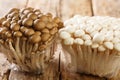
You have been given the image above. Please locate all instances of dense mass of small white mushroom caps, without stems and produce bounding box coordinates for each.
[59,16,120,51]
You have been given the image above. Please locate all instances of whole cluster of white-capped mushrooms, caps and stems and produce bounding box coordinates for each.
[59,15,120,78]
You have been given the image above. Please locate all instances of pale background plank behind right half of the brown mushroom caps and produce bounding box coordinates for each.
[27,0,59,16]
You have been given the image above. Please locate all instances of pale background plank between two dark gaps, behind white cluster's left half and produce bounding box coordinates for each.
[60,0,92,20]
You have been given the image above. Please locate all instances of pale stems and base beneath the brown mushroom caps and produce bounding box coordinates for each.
[0,38,56,74]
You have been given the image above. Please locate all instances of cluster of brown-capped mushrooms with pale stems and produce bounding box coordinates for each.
[0,7,63,73]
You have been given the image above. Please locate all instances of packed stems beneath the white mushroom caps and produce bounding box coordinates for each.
[62,44,120,78]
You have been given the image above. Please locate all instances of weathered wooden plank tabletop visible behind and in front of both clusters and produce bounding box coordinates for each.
[0,0,120,80]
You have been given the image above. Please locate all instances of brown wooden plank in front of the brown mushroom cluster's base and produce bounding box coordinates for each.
[9,63,59,80]
